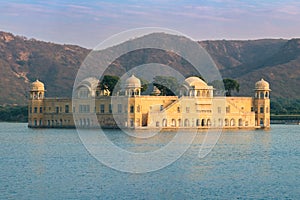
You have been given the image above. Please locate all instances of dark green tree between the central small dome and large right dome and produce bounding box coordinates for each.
[153,76,180,96]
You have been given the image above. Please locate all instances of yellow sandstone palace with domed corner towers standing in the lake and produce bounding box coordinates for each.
[28,75,271,129]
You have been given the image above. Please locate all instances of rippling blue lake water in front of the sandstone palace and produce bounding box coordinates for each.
[0,123,300,199]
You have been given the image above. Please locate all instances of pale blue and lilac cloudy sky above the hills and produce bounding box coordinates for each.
[0,0,300,48]
